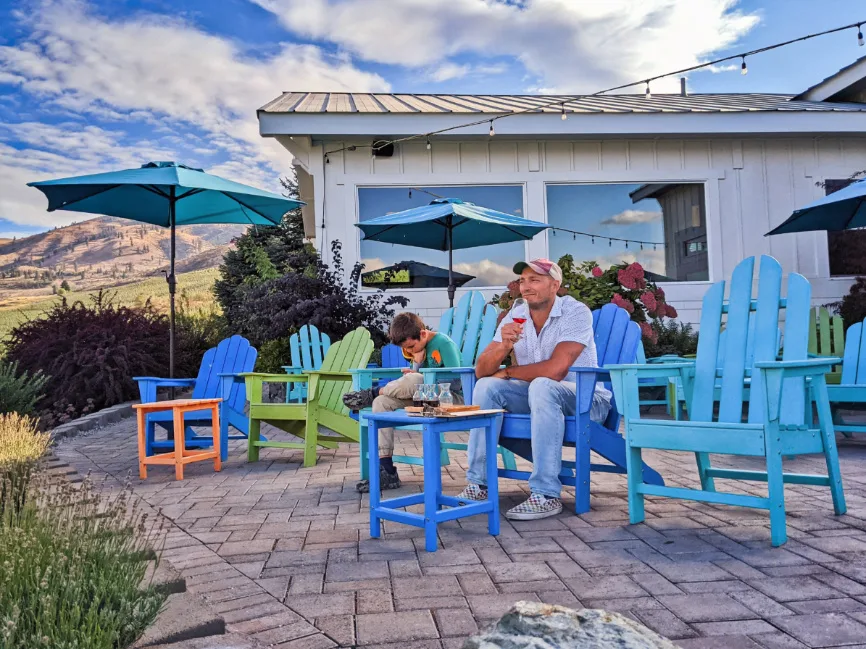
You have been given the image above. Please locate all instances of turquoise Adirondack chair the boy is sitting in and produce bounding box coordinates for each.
[353,291,517,479]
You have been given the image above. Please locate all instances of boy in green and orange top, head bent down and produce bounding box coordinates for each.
[343,312,463,493]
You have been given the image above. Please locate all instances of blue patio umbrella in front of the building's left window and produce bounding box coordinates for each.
[355,198,550,306]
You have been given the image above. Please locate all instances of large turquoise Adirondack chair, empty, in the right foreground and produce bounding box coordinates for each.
[608,256,845,546]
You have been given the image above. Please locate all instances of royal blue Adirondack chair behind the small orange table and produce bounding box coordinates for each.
[133,336,258,461]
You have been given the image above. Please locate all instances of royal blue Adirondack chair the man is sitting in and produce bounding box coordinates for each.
[464,304,664,514]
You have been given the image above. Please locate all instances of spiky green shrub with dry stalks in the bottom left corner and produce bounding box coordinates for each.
[0,470,165,649]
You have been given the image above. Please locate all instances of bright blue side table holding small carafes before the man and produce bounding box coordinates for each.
[365,410,502,552]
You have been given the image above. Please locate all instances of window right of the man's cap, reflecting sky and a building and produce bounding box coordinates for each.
[547,183,710,282]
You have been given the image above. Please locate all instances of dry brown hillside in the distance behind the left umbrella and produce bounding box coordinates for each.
[0,217,245,309]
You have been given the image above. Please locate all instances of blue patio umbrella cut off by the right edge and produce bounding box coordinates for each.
[764,180,866,236]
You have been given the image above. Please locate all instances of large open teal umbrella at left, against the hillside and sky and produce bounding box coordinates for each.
[27,162,303,377]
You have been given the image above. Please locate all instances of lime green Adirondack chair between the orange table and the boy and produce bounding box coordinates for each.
[244,327,373,467]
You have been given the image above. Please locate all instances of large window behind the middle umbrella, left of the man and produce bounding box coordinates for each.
[358,185,526,288]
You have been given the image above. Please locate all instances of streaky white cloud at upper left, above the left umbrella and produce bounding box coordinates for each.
[0,0,389,224]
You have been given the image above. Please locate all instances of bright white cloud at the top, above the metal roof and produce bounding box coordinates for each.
[253,0,758,92]
